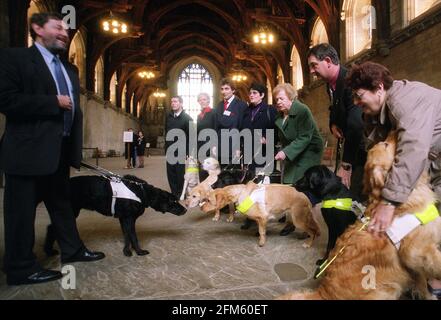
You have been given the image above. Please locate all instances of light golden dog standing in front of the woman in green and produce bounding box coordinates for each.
[201,182,320,247]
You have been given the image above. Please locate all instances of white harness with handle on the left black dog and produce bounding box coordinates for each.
[81,162,144,216]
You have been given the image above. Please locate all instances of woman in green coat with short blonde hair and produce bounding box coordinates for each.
[274,83,324,184]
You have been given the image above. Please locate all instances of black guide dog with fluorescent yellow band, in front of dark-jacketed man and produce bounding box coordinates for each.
[294,165,357,265]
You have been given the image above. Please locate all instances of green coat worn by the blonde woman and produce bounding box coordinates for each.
[276,100,324,184]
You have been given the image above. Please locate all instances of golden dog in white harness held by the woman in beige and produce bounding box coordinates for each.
[365,131,441,299]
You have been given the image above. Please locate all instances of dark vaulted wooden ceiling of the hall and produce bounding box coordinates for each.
[12,0,340,109]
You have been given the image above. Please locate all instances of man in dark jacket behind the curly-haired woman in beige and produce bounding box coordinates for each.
[308,43,366,200]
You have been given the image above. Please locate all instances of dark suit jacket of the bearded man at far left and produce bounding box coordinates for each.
[0,46,83,175]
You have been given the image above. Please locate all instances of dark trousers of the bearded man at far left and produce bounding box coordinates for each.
[4,142,84,277]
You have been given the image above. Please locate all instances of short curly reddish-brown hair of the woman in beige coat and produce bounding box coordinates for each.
[346,61,394,91]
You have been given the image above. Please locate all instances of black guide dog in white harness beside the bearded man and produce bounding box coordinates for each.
[44,175,187,257]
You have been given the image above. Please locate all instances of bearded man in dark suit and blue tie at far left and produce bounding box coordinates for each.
[0,13,104,285]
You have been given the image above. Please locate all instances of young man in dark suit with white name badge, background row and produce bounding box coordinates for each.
[215,78,247,165]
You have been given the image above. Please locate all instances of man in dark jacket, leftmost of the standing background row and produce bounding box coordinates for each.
[165,96,193,198]
